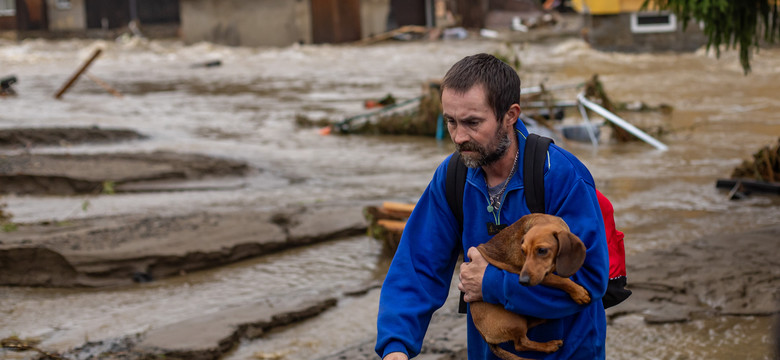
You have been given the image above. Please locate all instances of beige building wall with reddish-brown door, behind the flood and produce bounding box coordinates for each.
[180,0,434,46]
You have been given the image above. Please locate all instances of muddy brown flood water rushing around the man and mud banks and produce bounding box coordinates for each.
[0,34,780,359]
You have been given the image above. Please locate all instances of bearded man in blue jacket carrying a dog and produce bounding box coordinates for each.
[376,54,609,360]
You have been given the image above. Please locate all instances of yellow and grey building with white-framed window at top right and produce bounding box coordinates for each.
[572,0,707,52]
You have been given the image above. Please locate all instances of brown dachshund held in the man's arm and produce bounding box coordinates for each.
[470,214,590,360]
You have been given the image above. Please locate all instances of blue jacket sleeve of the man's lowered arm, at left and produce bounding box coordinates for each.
[375,161,461,356]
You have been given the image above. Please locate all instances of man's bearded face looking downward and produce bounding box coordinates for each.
[441,85,512,168]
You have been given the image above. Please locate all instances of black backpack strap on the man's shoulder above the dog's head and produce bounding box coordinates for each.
[523,134,553,213]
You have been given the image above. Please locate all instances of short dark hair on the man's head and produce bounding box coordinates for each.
[441,53,520,123]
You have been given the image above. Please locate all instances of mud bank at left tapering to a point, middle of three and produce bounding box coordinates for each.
[0,148,250,195]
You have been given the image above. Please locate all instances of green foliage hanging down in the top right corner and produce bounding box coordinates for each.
[643,0,780,74]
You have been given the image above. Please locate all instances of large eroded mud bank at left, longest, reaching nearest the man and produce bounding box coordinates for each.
[0,204,366,287]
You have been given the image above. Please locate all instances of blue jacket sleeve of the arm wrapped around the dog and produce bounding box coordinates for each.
[482,151,609,319]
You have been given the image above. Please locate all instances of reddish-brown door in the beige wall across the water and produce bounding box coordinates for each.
[311,0,360,44]
